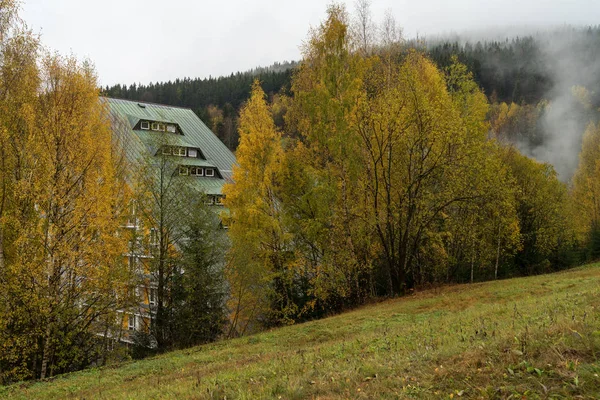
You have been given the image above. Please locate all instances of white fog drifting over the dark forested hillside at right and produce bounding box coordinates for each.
[428,26,600,182]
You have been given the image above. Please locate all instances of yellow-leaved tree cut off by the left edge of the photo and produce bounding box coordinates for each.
[0,0,40,382]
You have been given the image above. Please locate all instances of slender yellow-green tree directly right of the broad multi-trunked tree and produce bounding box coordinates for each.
[446,56,521,282]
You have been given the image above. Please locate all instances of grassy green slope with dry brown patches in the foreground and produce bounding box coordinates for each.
[0,265,600,399]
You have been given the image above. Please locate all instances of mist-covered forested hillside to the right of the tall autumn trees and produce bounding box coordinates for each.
[428,27,600,181]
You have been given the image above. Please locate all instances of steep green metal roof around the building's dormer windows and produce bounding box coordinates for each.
[104,98,236,194]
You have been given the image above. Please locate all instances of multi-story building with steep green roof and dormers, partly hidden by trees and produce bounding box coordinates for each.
[105,98,236,342]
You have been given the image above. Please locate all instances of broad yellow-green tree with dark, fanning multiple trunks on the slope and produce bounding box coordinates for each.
[359,52,502,293]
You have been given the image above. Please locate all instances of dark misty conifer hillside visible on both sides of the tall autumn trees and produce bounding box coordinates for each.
[104,26,600,182]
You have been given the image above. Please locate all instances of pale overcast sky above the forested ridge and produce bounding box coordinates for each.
[22,0,600,85]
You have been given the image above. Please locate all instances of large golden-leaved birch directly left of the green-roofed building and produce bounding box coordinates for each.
[0,56,129,380]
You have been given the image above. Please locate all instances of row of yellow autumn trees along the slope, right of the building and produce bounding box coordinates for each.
[224,5,598,334]
